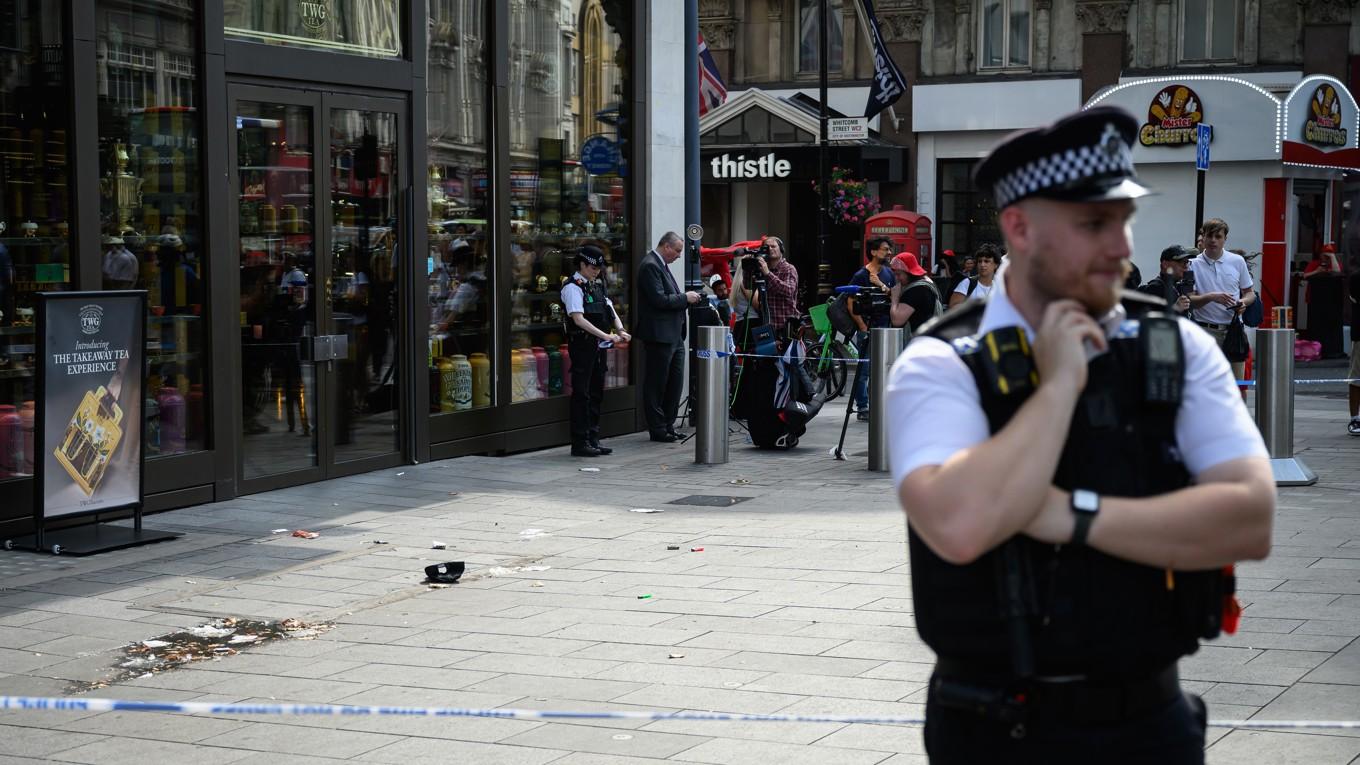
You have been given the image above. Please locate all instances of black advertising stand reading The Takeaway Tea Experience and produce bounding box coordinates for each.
[4,290,181,555]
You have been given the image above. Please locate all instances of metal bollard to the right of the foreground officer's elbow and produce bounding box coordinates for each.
[1257,329,1318,486]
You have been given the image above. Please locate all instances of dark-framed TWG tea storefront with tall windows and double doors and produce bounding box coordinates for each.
[0,0,656,535]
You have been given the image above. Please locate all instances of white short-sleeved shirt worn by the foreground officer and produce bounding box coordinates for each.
[887,274,1269,485]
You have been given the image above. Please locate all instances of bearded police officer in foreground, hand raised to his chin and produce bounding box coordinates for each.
[888,108,1276,764]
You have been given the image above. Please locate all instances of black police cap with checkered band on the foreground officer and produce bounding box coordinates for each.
[972,106,1152,210]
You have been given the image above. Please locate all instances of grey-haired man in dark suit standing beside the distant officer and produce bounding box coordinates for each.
[634,231,700,444]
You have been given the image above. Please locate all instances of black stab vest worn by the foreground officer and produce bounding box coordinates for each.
[907,293,1231,677]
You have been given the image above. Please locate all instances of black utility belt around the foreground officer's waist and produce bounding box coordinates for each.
[930,657,1180,724]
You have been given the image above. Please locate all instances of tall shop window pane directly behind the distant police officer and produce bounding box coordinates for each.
[498,0,632,402]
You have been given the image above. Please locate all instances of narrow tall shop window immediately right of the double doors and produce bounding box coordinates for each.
[426,0,496,412]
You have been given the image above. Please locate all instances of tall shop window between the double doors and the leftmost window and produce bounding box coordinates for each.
[95,0,209,457]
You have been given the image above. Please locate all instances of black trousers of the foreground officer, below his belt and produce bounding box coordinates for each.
[925,683,1206,765]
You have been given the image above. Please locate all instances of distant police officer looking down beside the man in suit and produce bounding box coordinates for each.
[562,245,631,457]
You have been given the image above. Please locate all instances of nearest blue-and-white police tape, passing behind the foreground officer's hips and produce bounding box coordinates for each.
[0,696,1360,730]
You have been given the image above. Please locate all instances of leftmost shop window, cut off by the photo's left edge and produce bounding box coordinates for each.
[0,0,71,481]
